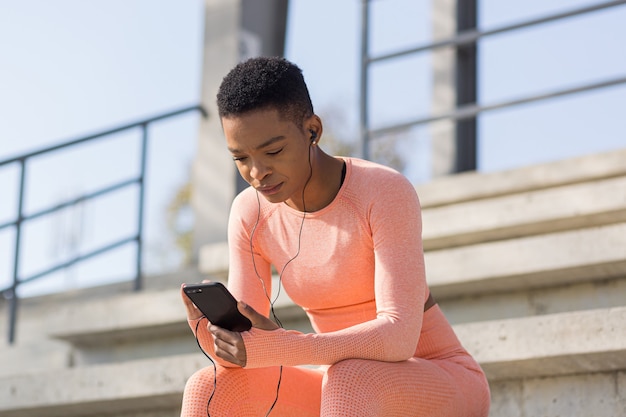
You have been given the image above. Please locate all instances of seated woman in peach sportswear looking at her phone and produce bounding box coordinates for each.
[182,58,489,417]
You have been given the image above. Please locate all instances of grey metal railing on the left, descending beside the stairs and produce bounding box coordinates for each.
[0,105,207,344]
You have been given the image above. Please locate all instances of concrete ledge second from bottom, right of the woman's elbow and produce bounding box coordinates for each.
[425,223,626,299]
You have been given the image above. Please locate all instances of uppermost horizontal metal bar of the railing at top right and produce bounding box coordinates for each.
[366,0,626,62]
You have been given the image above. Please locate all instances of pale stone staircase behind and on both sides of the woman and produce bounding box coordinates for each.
[0,150,626,417]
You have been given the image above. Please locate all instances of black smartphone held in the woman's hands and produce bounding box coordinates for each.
[183,282,252,332]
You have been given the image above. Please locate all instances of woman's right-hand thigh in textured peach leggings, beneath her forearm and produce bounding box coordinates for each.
[322,358,489,417]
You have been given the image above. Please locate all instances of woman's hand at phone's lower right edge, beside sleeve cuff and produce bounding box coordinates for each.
[208,301,278,367]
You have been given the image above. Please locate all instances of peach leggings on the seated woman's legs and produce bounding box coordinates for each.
[181,357,489,417]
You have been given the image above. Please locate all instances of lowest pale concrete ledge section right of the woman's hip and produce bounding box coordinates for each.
[454,307,626,381]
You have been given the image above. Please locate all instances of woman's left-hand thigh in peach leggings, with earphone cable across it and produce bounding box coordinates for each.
[181,367,323,417]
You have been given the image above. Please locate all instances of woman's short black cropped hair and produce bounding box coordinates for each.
[217,57,313,127]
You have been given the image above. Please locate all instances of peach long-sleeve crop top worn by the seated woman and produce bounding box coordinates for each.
[192,158,468,368]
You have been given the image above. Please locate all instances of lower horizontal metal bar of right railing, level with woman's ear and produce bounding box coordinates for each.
[369,76,626,137]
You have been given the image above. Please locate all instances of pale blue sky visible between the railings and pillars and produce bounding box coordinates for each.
[0,0,626,294]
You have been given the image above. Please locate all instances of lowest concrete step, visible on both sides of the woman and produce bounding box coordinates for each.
[0,307,626,417]
